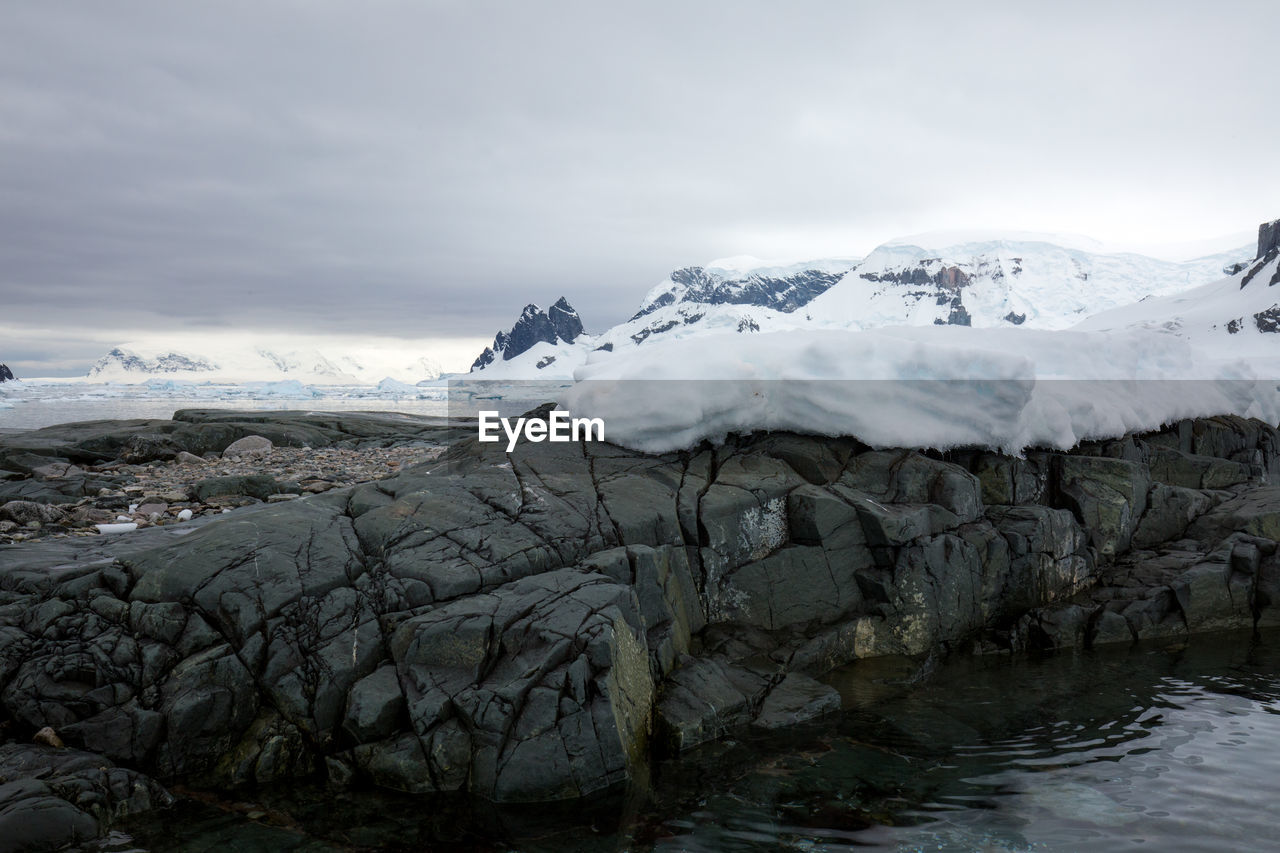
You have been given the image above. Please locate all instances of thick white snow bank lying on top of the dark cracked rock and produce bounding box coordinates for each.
[558,327,1280,453]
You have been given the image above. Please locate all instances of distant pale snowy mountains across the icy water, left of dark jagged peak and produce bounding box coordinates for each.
[88,341,440,384]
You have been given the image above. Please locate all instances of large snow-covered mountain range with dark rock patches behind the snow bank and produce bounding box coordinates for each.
[472,225,1253,379]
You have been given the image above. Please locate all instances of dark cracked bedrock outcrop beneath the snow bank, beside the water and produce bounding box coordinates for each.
[0,418,1280,802]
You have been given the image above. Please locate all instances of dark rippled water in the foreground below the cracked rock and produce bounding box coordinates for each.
[113,633,1280,853]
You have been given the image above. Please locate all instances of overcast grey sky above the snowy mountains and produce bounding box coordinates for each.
[0,0,1280,375]
